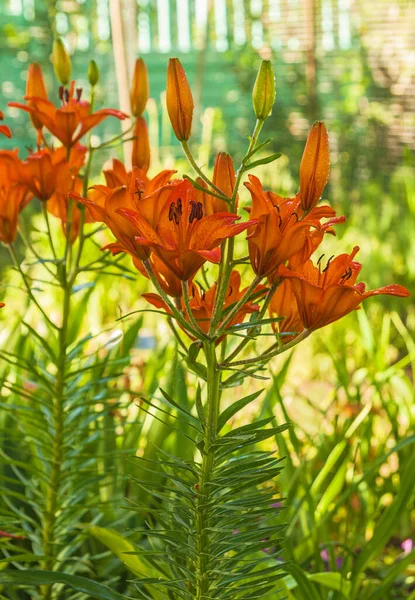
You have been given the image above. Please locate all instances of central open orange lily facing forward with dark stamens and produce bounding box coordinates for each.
[118,180,253,281]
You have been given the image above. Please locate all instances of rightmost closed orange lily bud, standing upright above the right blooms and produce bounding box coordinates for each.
[300,121,330,212]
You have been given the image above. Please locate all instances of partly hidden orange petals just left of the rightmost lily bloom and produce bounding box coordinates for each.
[269,279,304,343]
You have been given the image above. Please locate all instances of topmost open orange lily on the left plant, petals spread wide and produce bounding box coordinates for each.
[9,81,127,148]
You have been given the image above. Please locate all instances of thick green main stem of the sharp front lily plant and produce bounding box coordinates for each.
[195,342,221,600]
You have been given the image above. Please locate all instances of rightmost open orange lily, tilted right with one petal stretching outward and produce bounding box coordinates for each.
[278,246,409,330]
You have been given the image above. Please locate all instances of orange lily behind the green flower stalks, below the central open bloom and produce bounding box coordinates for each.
[143,271,265,343]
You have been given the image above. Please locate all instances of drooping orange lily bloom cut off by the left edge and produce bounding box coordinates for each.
[0,150,30,244]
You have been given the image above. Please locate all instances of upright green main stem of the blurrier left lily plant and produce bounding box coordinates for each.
[42,284,72,600]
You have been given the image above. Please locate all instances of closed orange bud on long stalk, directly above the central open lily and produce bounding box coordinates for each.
[166,58,194,142]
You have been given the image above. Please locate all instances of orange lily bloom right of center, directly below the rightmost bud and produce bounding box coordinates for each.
[245,175,336,277]
